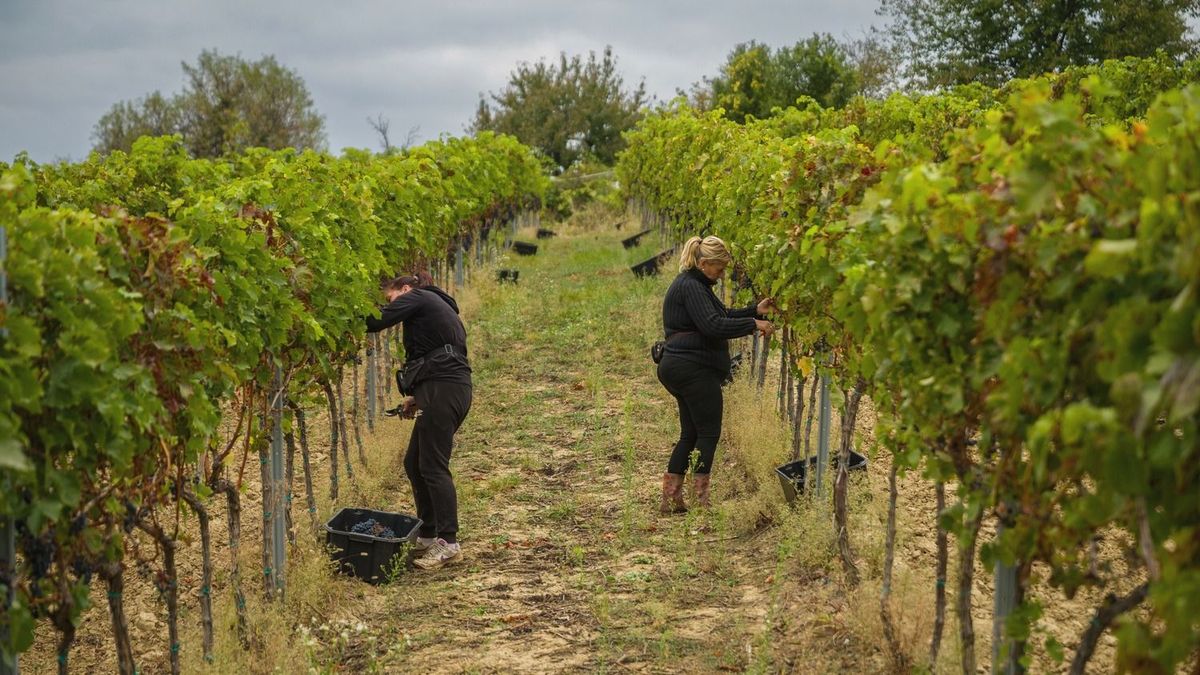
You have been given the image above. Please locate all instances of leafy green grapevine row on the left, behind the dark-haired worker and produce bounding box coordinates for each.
[0,133,546,671]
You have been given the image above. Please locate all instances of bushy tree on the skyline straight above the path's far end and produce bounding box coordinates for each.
[470,47,647,169]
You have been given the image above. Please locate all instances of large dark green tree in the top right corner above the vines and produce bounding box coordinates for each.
[880,0,1200,88]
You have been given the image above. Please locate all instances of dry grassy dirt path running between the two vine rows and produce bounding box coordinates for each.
[343,224,782,671]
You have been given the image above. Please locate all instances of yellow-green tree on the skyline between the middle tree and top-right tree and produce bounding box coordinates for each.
[692,34,882,123]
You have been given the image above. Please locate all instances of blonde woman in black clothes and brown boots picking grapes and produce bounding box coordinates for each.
[659,237,775,513]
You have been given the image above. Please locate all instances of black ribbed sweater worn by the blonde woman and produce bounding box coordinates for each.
[662,268,757,376]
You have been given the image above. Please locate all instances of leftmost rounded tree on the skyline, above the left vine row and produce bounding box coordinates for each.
[92,50,325,157]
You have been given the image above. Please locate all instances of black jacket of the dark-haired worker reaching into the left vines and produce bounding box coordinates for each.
[366,286,470,384]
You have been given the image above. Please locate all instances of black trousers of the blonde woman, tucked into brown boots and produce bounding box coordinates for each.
[659,354,725,473]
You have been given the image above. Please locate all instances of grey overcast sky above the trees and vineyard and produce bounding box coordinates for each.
[0,0,880,161]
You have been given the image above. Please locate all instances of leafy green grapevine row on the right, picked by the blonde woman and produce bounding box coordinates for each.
[617,59,1200,671]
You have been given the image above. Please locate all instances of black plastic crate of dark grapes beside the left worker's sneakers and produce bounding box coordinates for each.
[325,508,421,584]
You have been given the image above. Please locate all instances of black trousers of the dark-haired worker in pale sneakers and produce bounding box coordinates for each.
[404,380,472,542]
